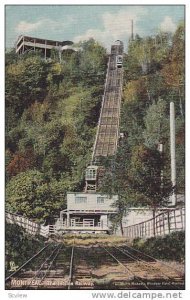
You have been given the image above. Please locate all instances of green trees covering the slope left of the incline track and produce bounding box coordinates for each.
[6,40,107,222]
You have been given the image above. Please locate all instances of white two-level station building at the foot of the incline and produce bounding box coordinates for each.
[56,193,118,233]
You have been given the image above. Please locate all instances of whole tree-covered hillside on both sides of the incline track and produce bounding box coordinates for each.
[6,25,185,222]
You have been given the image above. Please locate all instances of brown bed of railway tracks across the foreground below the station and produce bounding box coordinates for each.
[6,242,184,290]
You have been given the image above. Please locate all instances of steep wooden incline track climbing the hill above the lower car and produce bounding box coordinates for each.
[92,41,123,162]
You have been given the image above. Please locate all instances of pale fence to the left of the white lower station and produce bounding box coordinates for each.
[5,212,51,237]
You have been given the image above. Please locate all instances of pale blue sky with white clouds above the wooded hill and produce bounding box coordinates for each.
[5,5,184,48]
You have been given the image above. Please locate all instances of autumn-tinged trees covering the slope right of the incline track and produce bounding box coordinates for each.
[102,25,184,223]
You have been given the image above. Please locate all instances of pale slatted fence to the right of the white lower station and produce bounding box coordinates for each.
[123,208,185,239]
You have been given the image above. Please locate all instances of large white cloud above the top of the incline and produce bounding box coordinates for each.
[74,7,147,47]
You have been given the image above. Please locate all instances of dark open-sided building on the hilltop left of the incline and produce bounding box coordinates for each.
[15,35,77,59]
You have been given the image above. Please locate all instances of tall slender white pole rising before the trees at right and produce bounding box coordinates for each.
[170,102,177,206]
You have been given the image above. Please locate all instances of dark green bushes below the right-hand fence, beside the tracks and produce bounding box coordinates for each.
[132,231,185,261]
